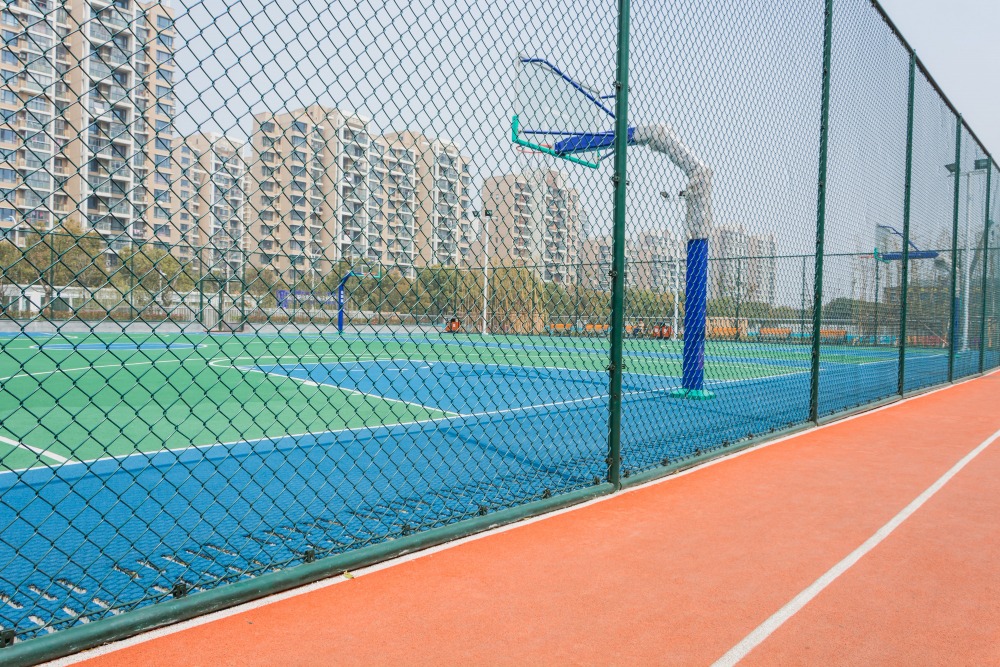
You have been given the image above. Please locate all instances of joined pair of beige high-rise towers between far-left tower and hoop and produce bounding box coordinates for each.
[246,106,477,282]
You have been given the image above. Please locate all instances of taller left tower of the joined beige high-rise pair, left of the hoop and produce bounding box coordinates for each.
[245,105,366,283]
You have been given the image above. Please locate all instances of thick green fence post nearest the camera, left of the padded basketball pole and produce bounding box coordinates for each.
[608,0,629,489]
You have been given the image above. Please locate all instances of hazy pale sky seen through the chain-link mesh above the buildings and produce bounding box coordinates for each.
[162,0,1000,306]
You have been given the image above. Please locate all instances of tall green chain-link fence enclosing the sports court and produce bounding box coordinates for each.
[0,0,1000,662]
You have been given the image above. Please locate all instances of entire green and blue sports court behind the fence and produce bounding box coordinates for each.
[0,331,978,636]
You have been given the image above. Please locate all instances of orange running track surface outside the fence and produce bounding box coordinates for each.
[58,375,1000,667]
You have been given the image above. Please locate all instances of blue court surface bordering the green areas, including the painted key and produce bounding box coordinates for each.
[0,341,996,637]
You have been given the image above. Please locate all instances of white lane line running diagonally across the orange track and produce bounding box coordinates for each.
[713,431,1000,667]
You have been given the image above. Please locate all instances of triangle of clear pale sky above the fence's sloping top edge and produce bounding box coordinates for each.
[882,0,1000,153]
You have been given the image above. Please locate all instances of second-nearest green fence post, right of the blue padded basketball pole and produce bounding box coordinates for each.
[809,0,833,421]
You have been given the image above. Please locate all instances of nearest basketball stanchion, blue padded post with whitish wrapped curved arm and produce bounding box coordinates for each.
[630,125,716,399]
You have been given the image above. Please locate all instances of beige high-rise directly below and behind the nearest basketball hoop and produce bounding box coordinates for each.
[482,169,588,283]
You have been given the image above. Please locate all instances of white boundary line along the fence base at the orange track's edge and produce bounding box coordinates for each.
[45,369,1000,667]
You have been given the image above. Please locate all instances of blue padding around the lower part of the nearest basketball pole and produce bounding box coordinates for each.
[672,239,715,399]
